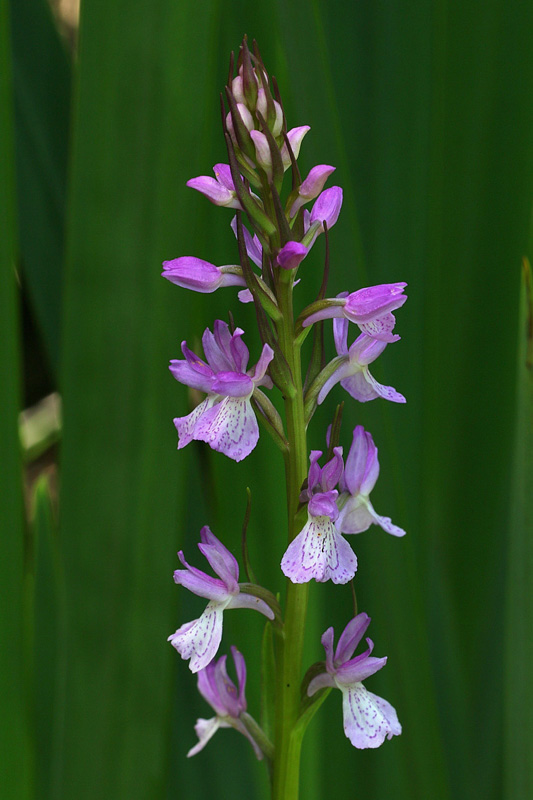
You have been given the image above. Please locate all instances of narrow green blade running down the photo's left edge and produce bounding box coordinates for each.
[0,2,33,800]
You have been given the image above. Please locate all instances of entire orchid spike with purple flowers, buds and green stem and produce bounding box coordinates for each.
[163,39,407,798]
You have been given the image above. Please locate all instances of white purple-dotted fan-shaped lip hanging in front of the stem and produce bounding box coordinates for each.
[281,516,357,583]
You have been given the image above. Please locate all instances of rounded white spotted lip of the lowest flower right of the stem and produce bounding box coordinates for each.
[342,683,401,749]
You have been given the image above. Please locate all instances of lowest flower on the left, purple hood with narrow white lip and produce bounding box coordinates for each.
[187,647,263,759]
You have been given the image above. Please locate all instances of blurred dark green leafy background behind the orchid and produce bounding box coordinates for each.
[0,0,533,800]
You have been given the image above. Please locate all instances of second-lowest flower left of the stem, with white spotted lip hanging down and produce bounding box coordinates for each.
[168,525,274,672]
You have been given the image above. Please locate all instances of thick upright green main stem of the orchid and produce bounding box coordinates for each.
[272,273,309,800]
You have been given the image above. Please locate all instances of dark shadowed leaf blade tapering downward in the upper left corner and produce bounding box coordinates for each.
[11,0,71,376]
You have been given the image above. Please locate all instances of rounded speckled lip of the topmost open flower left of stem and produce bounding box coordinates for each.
[194,397,259,461]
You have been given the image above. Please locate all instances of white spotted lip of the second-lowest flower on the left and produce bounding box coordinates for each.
[168,600,227,672]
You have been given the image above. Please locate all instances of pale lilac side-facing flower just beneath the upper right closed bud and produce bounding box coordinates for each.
[317,318,405,405]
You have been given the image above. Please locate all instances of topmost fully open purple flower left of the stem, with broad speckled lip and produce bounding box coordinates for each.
[170,320,274,461]
